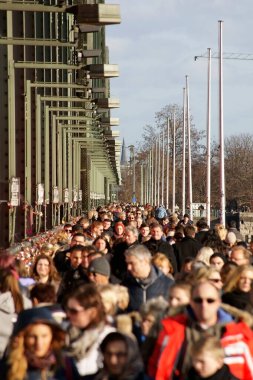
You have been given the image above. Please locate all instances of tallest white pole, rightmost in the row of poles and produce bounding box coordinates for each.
[219,21,226,226]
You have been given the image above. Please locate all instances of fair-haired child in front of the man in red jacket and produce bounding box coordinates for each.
[186,336,238,380]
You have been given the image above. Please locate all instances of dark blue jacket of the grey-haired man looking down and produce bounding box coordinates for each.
[122,265,174,311]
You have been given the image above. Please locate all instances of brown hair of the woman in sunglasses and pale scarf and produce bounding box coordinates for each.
[66,284,106,326]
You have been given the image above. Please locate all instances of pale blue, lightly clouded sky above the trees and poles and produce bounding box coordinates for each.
[106,0,253,145]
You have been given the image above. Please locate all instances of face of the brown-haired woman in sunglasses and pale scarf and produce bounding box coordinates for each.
[66,298,96,329]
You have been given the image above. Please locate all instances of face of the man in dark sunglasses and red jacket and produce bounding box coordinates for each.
[190,283,221,326]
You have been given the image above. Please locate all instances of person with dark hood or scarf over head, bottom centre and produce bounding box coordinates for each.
[95,331,147,380]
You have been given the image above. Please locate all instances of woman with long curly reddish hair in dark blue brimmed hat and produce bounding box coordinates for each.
[0,308,77,380]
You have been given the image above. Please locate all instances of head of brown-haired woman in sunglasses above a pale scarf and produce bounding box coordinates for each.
[65,284,105,329]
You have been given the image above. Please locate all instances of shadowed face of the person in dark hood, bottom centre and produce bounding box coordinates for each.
[104,341,127,376]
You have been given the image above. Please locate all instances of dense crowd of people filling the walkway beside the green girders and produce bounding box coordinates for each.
[0,203,253,380]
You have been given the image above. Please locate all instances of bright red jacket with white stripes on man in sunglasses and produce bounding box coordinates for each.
[148,314,253,380]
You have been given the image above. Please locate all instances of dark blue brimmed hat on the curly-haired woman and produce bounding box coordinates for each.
[12,307,63,336]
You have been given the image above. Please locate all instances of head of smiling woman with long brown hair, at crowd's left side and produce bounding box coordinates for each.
[32,255,60,292]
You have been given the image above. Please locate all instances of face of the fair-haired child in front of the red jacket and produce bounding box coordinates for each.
[192,351,223,378]
